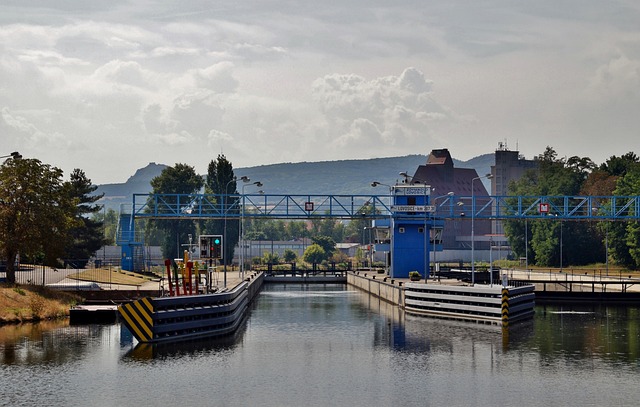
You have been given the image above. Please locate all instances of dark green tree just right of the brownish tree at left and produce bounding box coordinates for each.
[65,168,105,268]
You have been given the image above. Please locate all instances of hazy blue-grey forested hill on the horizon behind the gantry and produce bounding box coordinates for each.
[96,154,494,210]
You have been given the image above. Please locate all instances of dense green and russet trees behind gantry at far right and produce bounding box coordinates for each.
[504,147,640,269]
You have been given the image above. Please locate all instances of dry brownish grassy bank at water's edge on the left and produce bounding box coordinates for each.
[0,285,82,324]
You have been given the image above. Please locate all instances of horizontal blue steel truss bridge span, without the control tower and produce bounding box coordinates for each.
[123,194,640,221]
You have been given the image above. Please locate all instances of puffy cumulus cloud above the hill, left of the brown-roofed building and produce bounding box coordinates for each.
[312,68,455,151]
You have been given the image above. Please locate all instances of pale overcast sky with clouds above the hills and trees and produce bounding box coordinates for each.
[0,0,640,184]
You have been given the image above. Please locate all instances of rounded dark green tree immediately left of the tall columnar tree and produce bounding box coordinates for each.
[149,164,204,259]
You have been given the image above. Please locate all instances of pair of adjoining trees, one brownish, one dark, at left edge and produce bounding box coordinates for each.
[0,158,104,283]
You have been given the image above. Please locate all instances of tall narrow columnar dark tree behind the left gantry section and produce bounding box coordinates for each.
[202,154,240,264]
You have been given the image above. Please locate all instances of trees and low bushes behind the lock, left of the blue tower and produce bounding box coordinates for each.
[144,154,370,264]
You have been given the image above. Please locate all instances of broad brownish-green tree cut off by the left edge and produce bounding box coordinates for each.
[0,159,78,283]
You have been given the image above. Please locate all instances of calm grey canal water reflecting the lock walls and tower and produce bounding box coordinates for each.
[0,285,640,407]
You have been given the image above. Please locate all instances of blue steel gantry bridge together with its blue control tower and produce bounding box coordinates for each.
[118,190,640,278]
